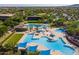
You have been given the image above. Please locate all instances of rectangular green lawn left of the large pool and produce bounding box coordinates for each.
[4,34,23,48]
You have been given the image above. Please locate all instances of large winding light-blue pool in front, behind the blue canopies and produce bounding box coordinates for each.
[24,34,74,55]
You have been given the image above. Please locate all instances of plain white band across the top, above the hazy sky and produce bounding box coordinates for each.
[0,0,79,5]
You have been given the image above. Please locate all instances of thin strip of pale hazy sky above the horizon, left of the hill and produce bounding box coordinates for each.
[0,4,72,7]
